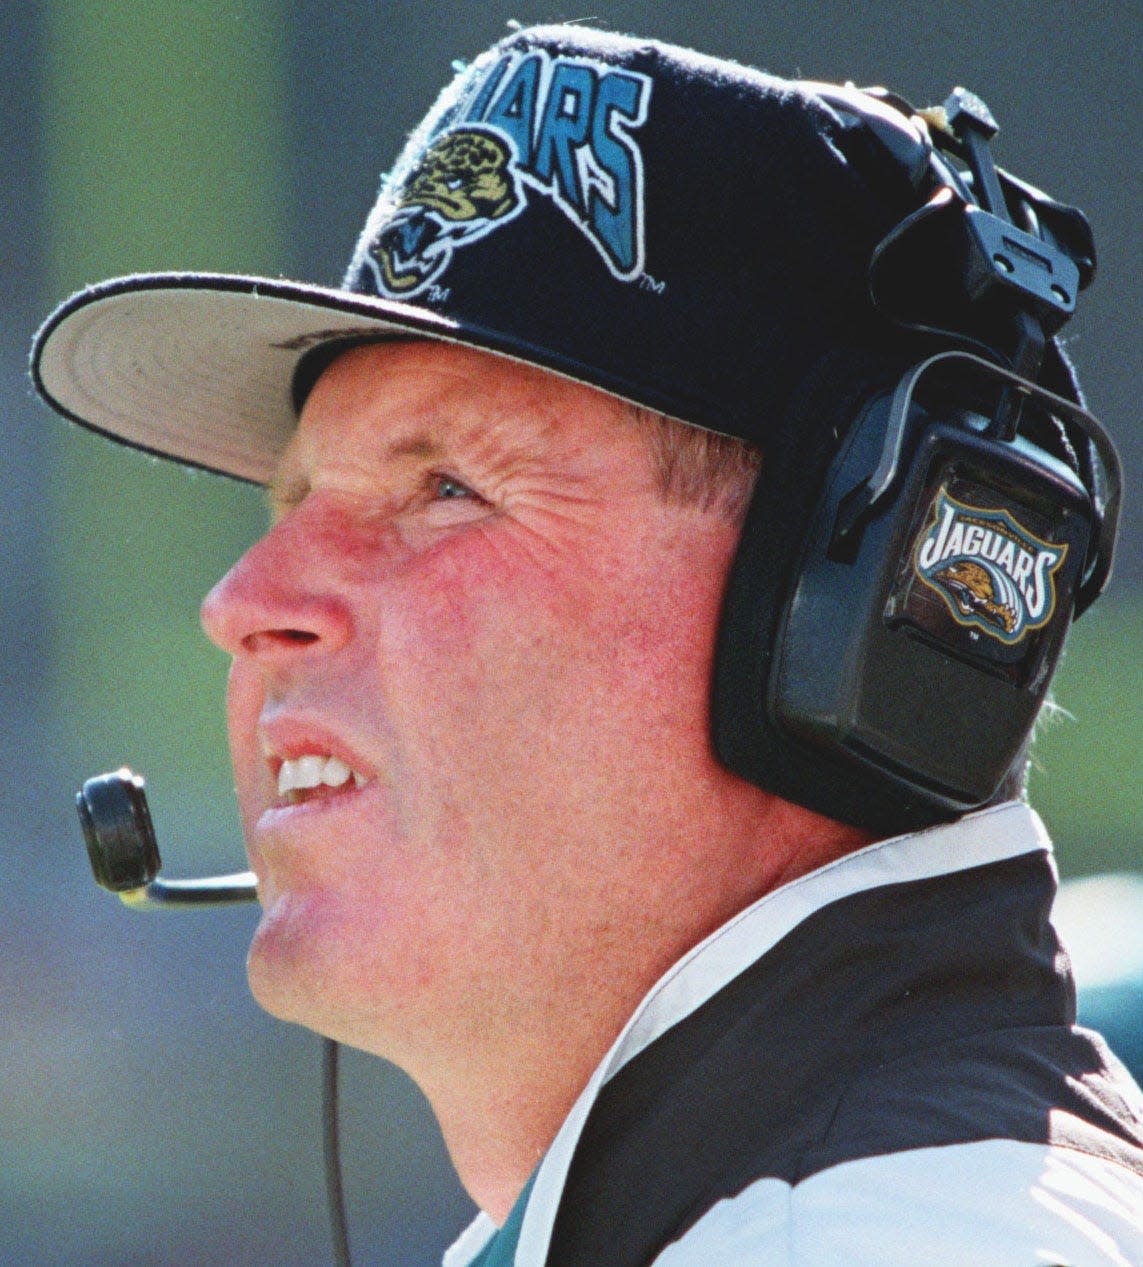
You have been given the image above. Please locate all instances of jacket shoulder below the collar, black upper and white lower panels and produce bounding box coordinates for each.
[655,1026,1143,1267]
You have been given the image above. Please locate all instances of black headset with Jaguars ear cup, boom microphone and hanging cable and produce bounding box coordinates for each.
[77,84,1121,1264]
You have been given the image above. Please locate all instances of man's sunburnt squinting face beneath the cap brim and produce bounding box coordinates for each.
[204,342,736,1068]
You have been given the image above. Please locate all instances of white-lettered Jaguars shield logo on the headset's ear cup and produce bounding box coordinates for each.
[914,487,1068,646]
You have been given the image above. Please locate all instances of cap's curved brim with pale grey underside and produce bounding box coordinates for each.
[32,274,558,484]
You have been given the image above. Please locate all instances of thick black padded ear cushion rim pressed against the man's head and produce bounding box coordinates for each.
[712,348,949,836]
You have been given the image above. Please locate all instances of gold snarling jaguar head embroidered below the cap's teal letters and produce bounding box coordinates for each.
[369,127,523,298]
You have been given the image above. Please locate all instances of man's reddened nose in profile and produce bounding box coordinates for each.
[201,516,352,666]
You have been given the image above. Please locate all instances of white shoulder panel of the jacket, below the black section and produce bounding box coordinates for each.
[655,1139,1143,1267]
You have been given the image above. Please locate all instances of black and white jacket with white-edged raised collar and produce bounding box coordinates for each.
[445,803,1143,1267]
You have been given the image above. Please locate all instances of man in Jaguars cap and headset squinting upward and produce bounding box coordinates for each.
[35,19,1143,1267]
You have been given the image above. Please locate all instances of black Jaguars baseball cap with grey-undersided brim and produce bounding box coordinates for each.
[32,25,921,483]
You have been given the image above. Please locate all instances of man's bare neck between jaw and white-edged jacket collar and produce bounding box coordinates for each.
[409,801,868,1225]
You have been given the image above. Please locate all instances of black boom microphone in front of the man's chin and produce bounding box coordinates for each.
[76,767,257,911]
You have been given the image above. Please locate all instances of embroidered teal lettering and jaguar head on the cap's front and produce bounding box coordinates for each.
[365,49,651,299]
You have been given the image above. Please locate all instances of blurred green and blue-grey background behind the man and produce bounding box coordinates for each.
[0,0,1143,1267]
